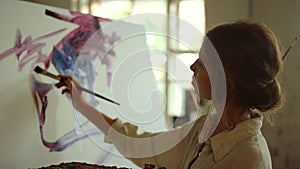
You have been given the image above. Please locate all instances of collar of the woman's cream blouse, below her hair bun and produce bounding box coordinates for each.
[209,117,263,162]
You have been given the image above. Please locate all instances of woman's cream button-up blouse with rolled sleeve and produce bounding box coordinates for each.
[105,117,272,169]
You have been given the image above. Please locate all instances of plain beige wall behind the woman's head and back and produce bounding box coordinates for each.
[206,0,300,169]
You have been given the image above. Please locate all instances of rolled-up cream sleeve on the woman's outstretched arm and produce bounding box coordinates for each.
[104,119,202,169]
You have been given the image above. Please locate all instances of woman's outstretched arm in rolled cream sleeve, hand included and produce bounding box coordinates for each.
[56,76,204,168]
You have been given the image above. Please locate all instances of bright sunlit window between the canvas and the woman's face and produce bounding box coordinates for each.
[72,0,205,125]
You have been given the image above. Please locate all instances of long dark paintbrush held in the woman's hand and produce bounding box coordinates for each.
[34,66,120,105]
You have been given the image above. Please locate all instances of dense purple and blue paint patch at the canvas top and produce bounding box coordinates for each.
[45,10,120,86]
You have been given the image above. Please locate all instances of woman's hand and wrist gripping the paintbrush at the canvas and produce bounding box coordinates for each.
[55,75,88,111]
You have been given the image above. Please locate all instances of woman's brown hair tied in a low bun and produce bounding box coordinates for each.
[206,21,283,117]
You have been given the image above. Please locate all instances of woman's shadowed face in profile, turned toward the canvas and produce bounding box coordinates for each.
[190,58,211,99]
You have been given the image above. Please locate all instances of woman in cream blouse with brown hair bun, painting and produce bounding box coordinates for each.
[56,21,282,169]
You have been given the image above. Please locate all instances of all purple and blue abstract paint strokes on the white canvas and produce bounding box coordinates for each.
[0,10,120,155]
